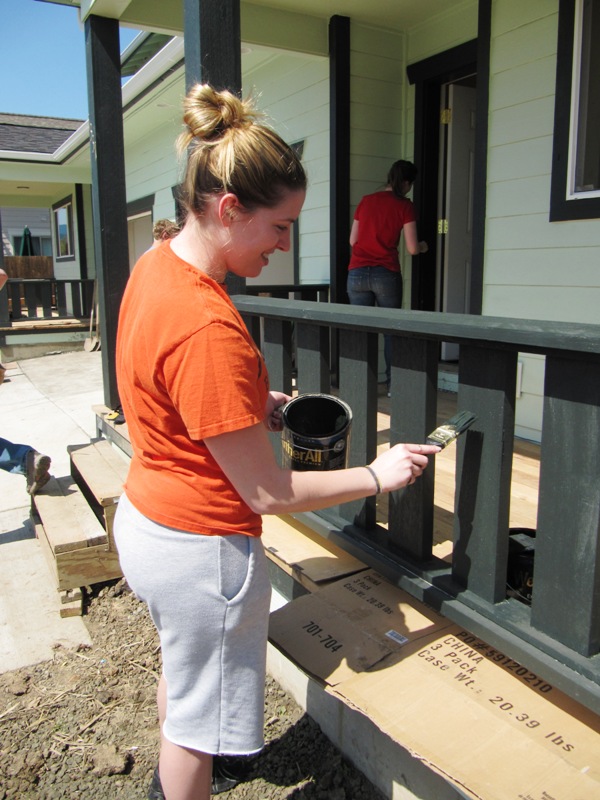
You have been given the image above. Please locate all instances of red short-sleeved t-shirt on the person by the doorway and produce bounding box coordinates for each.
[348,191,416,272]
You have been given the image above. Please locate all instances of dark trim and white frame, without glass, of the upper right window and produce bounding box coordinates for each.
[550,0,600,222]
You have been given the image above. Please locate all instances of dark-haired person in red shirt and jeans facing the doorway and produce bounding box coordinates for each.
[347,161,428,395]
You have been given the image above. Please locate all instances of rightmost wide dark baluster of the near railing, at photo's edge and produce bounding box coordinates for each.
[531,356,600,656]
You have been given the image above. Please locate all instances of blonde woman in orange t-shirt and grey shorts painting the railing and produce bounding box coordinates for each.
[115,85,438,800]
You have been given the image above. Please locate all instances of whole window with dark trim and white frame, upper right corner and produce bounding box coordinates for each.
[550,0,600,220]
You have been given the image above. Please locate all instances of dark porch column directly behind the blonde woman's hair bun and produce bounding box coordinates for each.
[183,0,246,295]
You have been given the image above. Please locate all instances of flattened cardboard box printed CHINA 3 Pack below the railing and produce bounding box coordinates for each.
[270,570,600,800]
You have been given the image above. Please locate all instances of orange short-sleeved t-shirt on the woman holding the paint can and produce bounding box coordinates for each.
[117,241,269,536]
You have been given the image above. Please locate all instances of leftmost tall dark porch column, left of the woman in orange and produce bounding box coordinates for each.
[85,15,129,408]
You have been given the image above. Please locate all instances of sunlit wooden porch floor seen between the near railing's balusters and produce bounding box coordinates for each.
[377,391,540,558]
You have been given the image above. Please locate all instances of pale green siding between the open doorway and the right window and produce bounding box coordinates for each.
[483,0,600,440]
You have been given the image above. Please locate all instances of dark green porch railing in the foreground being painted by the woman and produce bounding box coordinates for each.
[233,296,600,713]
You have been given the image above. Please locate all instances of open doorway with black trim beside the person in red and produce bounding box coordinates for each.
[407,36,489,328]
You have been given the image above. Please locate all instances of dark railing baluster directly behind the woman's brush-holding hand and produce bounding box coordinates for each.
[388,336,439,561]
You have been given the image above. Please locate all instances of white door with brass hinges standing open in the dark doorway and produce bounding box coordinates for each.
[436,76,476,361]
